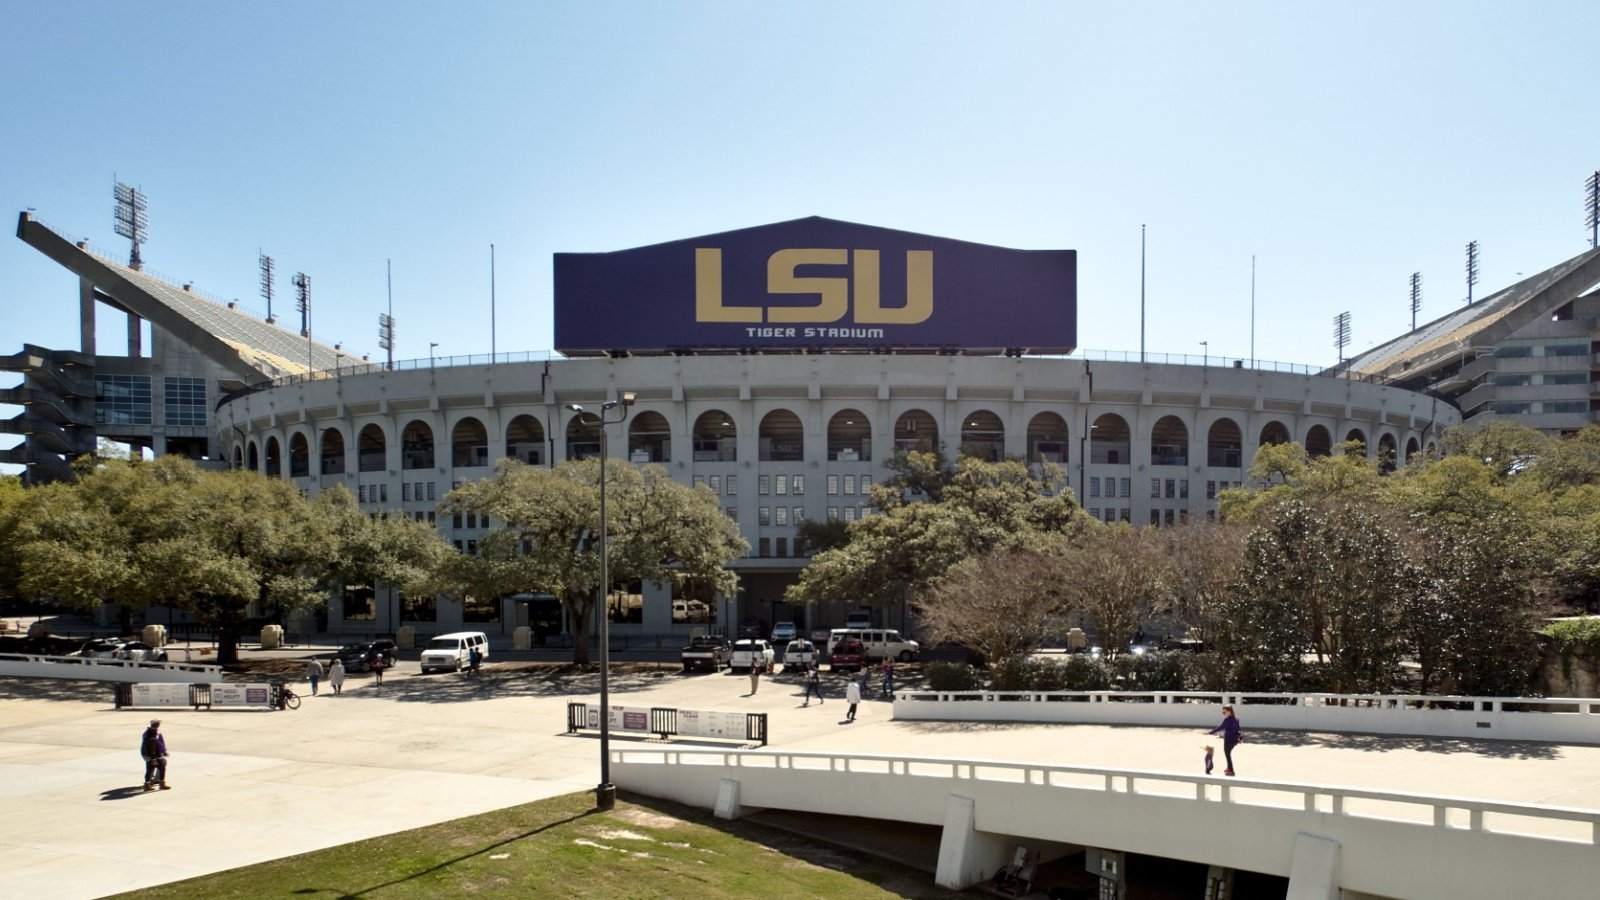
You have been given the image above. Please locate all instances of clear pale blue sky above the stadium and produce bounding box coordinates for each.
[0,0,1600,374]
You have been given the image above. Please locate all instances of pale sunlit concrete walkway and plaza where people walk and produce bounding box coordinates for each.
[0,661,1600,898]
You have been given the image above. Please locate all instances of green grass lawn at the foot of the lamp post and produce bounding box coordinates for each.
[122,791,958,900]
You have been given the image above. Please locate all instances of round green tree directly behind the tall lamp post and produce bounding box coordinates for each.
[443,460,750,663]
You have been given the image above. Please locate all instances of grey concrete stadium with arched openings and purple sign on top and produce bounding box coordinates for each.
[0,213,1548,641]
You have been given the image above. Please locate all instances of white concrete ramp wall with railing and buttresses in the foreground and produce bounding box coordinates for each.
[611,749,1600,900]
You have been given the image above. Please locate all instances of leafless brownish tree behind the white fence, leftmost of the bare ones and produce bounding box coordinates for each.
[922,549,1066,666]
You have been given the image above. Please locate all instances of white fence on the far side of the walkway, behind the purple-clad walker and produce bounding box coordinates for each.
[894,690,1600,745]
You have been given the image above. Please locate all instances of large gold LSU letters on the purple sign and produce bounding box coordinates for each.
[694,247,933,325]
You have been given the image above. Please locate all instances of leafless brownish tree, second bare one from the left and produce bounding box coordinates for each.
[1056,522,1176,657]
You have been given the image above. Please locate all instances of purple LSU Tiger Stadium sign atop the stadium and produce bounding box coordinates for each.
[555,218,1078,356]
